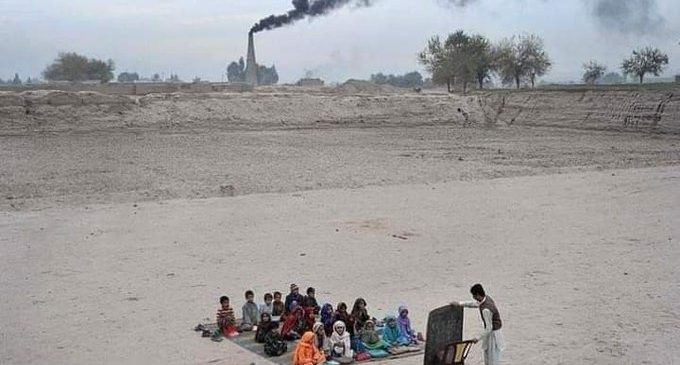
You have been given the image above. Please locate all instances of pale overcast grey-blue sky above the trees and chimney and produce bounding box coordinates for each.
[0,0,680,82]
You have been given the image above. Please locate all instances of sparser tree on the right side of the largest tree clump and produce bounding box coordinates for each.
[495,34,552,89]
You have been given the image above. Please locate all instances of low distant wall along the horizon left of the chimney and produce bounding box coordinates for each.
[0,82,253,95]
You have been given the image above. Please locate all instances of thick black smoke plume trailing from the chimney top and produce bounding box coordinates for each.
[250,0,373,33]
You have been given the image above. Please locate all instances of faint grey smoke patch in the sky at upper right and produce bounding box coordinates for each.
[591,0,664,34]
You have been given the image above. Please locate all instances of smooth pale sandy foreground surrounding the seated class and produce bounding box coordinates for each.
[0,167,680,364]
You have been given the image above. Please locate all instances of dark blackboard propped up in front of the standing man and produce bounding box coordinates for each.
[424,305,463,365]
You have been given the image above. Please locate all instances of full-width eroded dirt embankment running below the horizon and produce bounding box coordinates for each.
[0,85,680,135]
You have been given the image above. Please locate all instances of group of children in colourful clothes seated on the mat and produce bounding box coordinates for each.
[213,284,423,365]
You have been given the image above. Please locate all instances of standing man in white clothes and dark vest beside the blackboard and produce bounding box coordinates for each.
[451,284,505,365]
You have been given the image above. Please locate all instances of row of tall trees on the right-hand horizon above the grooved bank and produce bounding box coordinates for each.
[418,30,668,92]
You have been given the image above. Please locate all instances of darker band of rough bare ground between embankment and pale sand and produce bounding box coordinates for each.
[0,125,680,211]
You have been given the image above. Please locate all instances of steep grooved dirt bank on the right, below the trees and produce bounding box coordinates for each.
[476,88,680,134]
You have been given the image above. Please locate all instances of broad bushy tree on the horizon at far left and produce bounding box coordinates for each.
[43,52,115,83]
